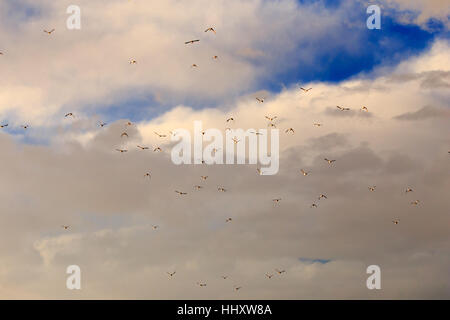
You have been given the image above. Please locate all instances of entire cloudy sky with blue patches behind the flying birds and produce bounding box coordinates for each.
[0,0,450,299]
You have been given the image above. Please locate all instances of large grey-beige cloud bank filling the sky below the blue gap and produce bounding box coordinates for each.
[0,38,450,299]
